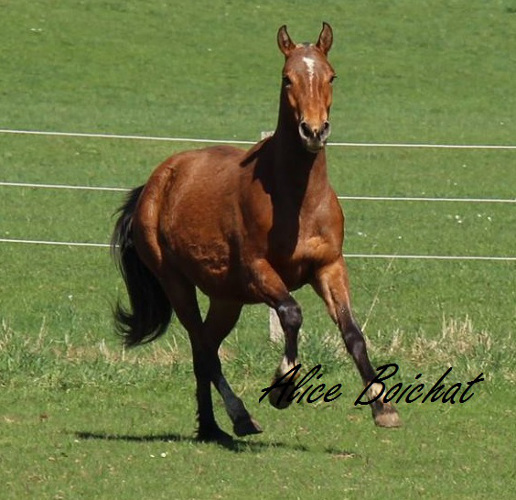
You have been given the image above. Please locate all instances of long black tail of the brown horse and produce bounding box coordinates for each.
[111,186,172,347]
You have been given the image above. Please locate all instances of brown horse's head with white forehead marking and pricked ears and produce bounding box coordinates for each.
[278,23,335,153]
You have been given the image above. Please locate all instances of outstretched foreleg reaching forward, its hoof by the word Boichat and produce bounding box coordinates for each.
[313,259,401,427]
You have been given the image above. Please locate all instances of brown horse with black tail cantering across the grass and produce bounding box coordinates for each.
[113,23,399,440]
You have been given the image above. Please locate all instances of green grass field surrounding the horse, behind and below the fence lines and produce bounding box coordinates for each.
[0,0,516,500]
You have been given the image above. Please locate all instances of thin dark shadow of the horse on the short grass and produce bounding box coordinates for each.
[73,431,357,457]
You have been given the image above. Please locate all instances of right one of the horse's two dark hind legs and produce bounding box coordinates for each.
[202,299,262,436]
